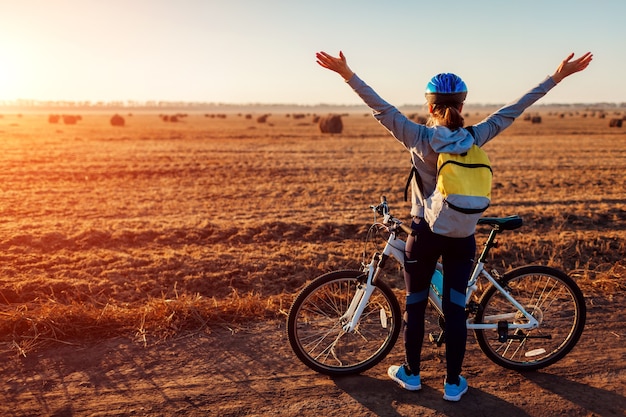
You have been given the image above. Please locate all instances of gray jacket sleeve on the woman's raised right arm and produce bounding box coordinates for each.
[473,77,556,146]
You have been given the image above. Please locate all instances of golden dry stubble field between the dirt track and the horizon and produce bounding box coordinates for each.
[0,111,626,353]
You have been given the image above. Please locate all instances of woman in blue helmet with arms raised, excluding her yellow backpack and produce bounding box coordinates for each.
[316,48,593,401]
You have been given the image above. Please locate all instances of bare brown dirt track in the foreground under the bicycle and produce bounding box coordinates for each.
[0,292,626,417]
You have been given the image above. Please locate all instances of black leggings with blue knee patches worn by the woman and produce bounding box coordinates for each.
[404,220,476,383]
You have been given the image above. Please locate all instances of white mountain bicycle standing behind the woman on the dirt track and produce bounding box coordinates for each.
[287,197,586,376]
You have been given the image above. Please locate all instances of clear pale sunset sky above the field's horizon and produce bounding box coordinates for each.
[0,0,626,106]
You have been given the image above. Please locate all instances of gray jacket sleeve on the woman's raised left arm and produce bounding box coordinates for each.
[347,74,429,153]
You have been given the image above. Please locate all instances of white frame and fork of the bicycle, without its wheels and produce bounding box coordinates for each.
[341,218,539,332]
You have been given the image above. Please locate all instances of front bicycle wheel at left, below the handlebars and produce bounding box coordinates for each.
[287,270,401,375]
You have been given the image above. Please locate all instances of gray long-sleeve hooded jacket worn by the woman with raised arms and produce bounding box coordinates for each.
[347,74,556,217]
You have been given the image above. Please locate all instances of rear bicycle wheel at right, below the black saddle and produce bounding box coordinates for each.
[475,266,586,371]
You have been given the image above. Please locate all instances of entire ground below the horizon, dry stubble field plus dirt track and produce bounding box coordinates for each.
[0,110,626,416]
